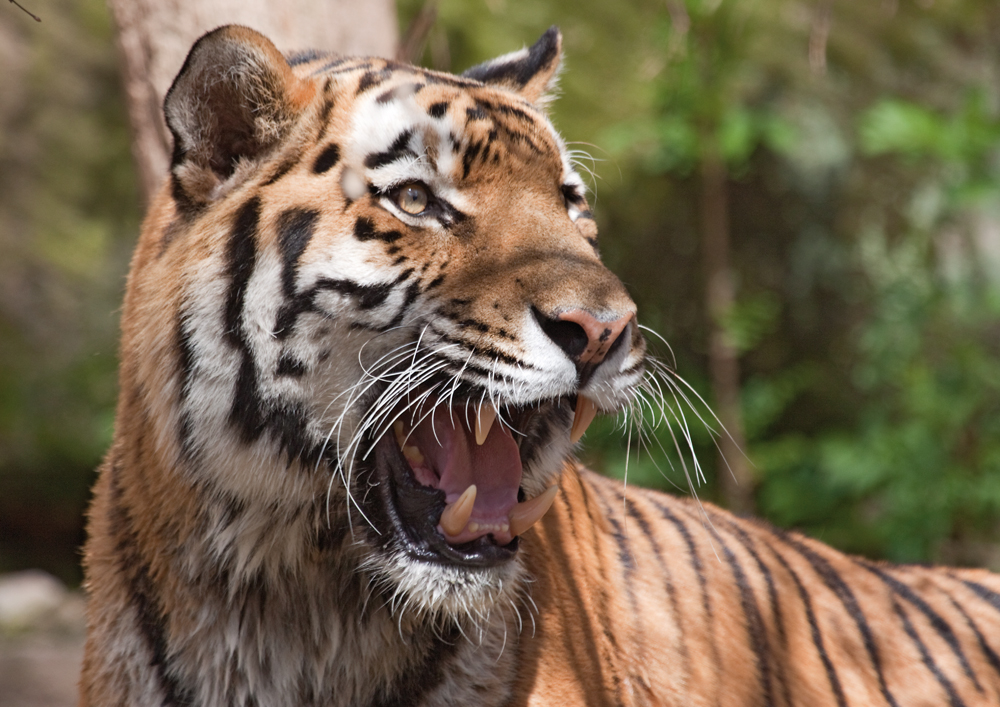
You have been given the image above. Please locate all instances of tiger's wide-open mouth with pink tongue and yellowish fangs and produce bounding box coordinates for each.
[375,396,596,567]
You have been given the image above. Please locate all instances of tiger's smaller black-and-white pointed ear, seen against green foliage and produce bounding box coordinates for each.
[462,25,562,104]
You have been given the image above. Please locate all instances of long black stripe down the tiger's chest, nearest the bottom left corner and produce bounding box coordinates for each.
[108,463,194,707]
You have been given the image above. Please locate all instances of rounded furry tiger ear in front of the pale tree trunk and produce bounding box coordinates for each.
[163,25,315,204]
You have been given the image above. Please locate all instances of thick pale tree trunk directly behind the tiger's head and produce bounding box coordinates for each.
[108,0,398,203]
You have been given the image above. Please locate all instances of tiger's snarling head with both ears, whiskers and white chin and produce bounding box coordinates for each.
[129,26,645,612]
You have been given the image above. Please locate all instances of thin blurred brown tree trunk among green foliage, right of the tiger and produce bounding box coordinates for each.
[701,154,754,514]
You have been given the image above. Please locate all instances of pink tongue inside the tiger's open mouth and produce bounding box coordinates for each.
[410,409,521,542]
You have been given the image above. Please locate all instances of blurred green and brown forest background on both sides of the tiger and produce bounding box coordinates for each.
[0,0,1000,586]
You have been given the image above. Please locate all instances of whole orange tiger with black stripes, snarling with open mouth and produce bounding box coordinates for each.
[80,26,1000,707]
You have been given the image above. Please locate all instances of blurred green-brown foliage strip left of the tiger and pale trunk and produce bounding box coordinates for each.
[0,0,140,580]
